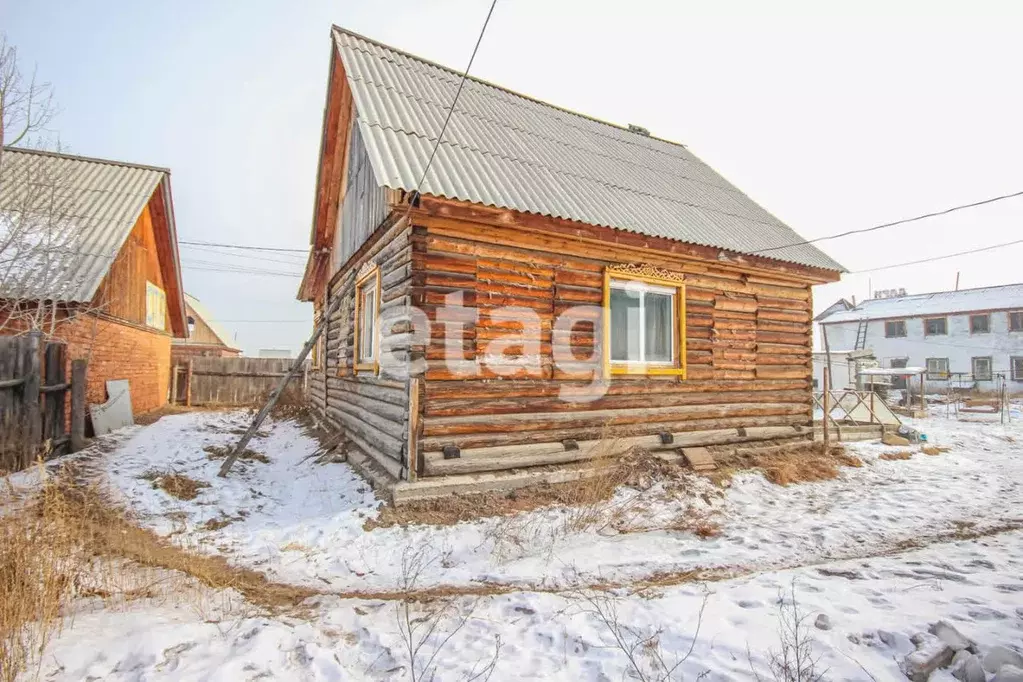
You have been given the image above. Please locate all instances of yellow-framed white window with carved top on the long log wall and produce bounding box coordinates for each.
[604,270,685,378]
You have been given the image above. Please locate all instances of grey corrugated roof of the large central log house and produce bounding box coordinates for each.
[333,27,843,270]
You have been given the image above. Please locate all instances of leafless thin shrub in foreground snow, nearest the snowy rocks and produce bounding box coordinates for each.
[747,578,828,682]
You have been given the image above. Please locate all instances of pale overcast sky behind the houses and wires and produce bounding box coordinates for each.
[0,0,1023,354]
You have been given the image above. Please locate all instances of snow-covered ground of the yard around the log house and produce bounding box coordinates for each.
[12,408,1023,680]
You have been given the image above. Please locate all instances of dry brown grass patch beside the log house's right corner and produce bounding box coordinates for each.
[710,443,863,486]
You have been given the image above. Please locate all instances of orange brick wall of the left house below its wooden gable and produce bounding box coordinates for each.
[54,315,171,414]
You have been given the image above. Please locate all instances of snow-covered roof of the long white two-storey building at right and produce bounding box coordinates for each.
[824,283,1023,324]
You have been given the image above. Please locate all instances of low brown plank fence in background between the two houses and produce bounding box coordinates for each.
[171,357,308,405]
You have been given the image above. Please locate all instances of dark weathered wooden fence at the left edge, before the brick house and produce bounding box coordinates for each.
[0,333,86,471]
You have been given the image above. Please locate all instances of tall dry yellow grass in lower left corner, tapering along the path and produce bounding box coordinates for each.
[0,470,315,682]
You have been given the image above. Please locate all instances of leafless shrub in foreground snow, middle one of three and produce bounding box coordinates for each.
[575,591,708,682]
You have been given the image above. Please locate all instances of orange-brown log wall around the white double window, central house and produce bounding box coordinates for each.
[412,212,812,475]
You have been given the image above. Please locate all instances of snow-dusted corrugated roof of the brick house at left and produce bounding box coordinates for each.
[0,148,169,303]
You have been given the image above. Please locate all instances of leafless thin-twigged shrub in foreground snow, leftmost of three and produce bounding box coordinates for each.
[395,547,501,682]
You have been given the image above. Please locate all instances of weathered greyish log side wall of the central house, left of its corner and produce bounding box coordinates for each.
[309,217,411,480]
